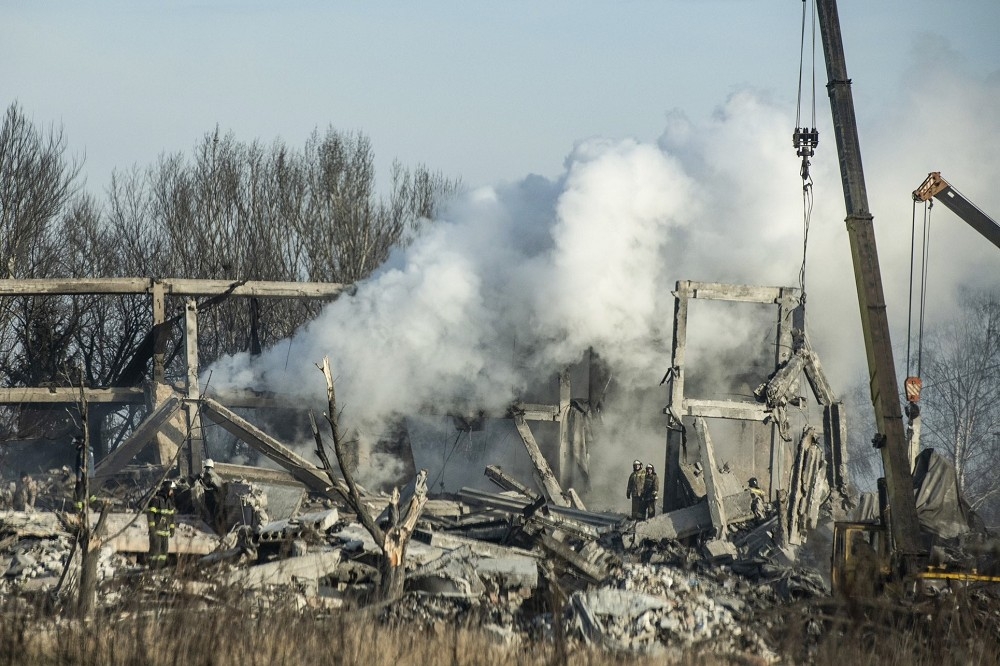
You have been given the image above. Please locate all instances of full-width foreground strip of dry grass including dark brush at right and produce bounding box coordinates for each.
[0,578,1000,666]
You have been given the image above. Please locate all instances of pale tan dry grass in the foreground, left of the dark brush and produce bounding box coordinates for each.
[0,584,745,666]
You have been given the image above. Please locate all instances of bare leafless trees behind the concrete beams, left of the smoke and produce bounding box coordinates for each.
[0,102,460,448]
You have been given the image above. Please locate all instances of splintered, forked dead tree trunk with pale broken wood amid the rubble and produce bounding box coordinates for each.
[309,358,427,602]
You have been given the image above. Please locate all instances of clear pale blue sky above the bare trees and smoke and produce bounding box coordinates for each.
[0,0,1000,192]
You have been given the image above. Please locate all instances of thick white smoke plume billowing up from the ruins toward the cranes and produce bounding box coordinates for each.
[209,40,1000,509]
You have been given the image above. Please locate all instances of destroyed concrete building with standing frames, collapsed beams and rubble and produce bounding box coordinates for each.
[0,274,876,655]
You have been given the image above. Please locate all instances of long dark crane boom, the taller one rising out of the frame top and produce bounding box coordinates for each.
[816,0,923,556]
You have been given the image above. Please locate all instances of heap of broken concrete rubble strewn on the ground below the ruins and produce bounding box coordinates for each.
[0,462,840,661]
